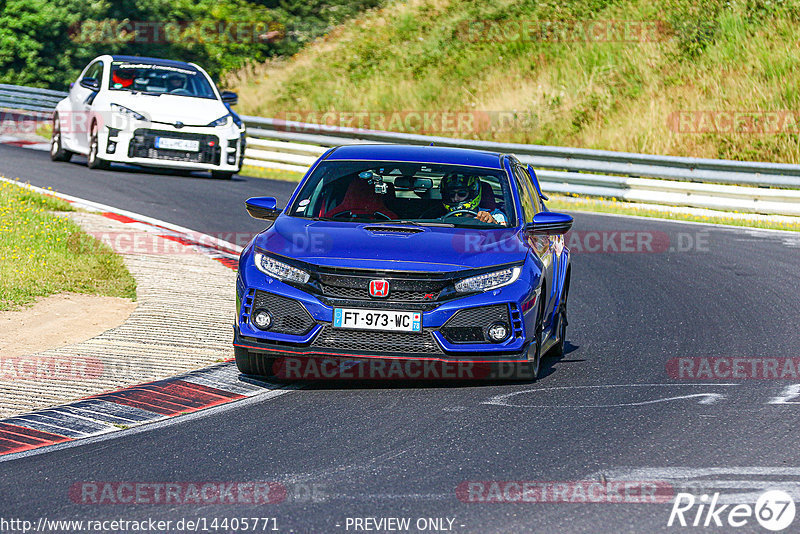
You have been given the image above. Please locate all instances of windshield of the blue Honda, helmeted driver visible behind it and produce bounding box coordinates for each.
[289,161,516,228]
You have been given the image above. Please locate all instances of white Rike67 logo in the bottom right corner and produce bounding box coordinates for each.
[667,490,795,532]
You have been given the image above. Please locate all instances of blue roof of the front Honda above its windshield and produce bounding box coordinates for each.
[326,144,503,169]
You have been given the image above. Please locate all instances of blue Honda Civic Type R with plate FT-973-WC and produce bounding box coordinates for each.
[234,145,572,377]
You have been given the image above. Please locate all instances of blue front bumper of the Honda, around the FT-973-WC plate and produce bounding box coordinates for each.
[234,261,537,363]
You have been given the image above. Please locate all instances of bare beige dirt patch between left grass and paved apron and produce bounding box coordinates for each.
[0,293,136,358]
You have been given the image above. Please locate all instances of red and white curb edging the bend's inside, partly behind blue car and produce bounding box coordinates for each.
[0,177,276,456]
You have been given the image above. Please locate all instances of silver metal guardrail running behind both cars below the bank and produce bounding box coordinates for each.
[0,84,800,216]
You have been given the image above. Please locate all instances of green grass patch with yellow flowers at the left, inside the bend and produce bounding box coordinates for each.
[0,182,136,310]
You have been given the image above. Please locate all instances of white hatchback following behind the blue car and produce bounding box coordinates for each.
[50,55,245,179]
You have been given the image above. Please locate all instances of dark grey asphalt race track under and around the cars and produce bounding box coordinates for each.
[0,147,800,533]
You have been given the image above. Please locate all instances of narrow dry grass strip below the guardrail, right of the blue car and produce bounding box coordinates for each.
[547,195,800,232]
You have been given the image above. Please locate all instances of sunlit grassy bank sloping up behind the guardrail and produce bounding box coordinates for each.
[227,0,800,163]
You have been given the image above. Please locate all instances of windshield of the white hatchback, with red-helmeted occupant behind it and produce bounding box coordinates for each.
[108,61,217,99]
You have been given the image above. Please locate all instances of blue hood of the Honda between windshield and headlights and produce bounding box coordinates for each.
[255,216,527,271]
